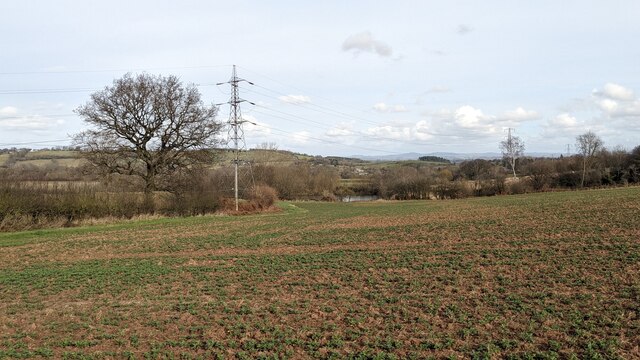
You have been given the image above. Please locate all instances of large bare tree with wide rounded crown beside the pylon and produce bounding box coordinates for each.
[75,74,221,192]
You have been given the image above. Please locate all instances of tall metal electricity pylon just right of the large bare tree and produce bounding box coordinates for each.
[217,65,255,211]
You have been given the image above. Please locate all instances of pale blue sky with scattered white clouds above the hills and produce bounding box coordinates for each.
[0,0,640,156]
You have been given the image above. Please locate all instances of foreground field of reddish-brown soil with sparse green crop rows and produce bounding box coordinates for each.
[0,187,640,359]
